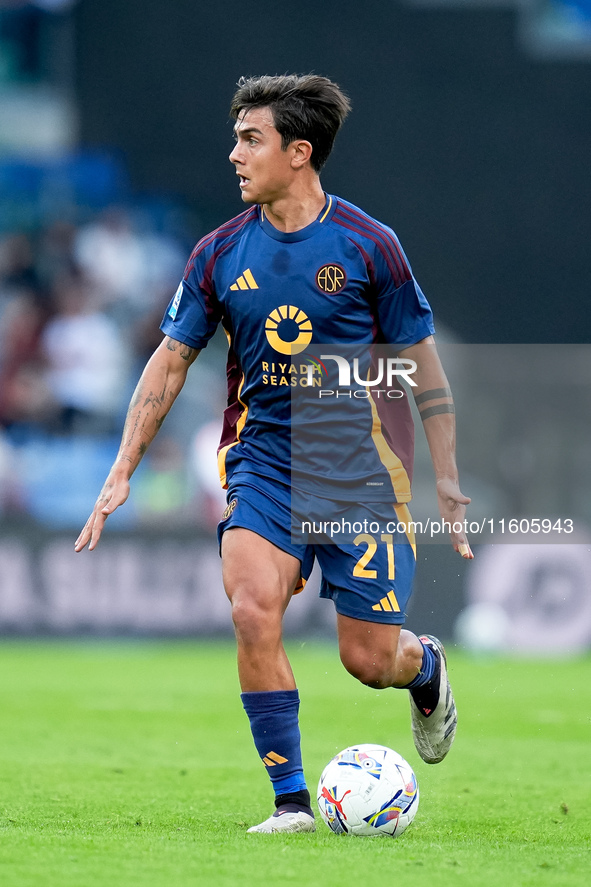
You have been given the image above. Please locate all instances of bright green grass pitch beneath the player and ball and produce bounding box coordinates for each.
[0,642,591,887]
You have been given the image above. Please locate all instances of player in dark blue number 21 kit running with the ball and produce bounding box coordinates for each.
[76,75,472,833]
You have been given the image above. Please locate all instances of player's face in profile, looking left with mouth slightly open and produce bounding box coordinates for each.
[230,108,294,203]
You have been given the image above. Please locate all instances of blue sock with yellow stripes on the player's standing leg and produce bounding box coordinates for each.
[240,690,306,795]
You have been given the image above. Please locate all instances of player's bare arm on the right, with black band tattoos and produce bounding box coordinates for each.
[398,336,474,559]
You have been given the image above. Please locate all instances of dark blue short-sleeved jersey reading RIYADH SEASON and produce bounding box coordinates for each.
[161,195,434,502]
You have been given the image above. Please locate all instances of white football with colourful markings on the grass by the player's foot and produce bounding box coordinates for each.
[318,744,419,838]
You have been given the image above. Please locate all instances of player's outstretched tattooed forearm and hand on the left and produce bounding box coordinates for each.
[75,336,199,551]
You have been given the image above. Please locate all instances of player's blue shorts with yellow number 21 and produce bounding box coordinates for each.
[218,471,416,625]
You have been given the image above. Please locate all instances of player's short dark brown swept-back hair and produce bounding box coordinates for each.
[230,74,351,172]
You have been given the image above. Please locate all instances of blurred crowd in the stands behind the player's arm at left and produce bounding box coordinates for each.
[0,206,223,527]
